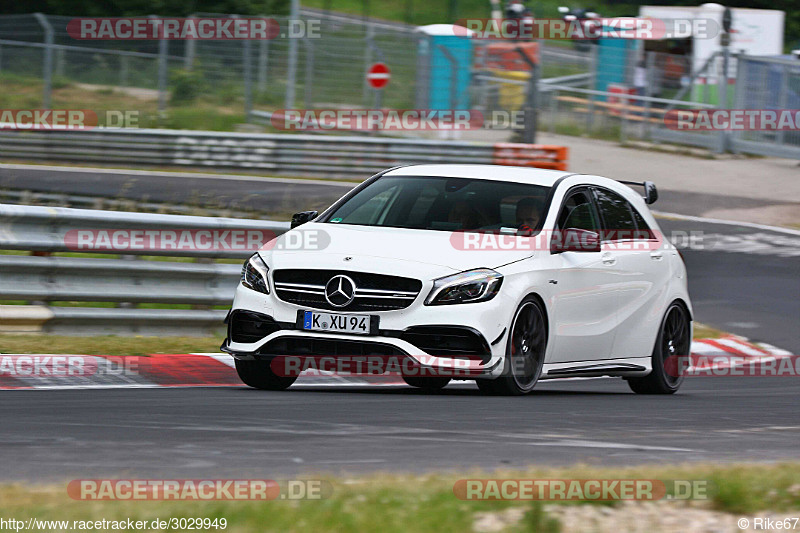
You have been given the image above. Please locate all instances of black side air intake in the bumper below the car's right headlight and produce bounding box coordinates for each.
[400,326,491,361]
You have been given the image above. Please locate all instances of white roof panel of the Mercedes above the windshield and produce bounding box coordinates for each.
[384,165,575,187]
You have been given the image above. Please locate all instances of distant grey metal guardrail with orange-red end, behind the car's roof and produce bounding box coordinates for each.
[0,129,567,178]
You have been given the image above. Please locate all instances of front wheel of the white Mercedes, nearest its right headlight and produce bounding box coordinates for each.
[475,296,547,396]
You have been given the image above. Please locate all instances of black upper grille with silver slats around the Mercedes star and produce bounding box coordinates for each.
[272,269,422,311]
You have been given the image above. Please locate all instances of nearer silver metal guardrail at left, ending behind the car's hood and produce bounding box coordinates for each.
[0,204,289,335]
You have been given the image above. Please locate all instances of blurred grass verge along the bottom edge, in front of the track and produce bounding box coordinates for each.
[0,462,800,533]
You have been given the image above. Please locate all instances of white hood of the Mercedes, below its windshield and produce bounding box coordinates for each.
[260,223,531,278]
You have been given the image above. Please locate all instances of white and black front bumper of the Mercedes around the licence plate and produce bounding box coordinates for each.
[221,284,514,379]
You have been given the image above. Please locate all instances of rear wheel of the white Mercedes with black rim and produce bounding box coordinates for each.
[627,301,692,394]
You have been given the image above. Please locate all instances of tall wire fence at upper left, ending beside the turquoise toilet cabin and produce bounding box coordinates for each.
[0,13,424,126]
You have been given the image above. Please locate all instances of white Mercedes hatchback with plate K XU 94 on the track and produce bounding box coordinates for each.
[222,165,692,394]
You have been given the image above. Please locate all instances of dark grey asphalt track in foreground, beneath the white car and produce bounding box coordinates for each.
[0,377,800,482]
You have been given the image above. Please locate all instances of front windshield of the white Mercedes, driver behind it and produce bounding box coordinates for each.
[325,176,550,231]
